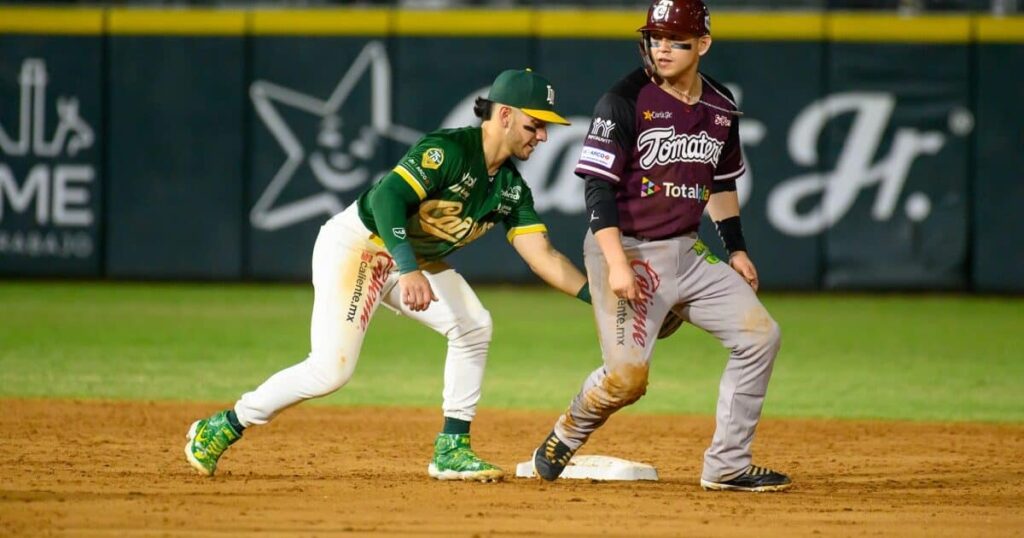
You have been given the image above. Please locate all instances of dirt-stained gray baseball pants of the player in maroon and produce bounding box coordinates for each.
[555,228,780,482]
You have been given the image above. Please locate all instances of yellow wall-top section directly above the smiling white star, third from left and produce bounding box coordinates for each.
[252,9,391,36]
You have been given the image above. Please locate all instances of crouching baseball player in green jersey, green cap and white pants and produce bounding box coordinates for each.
[185,70,590,482]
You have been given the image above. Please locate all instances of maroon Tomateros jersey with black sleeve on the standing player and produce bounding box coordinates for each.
[575,70,745,239]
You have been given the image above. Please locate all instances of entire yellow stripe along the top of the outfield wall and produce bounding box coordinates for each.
[0,7,1024,43]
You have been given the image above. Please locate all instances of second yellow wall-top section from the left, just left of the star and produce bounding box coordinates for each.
[110,9,247,36]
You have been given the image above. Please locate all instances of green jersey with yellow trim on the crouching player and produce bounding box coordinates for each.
[355,127,547,261]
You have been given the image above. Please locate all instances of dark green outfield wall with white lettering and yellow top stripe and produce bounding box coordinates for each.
[0,7,1024,292]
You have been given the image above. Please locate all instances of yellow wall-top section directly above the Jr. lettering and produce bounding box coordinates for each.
[826,13,971,43]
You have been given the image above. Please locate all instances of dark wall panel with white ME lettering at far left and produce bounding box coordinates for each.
[0,35,105,277]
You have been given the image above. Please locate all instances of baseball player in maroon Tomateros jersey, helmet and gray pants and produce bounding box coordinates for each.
[534,0,790,491]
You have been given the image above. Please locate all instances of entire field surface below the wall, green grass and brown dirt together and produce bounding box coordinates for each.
[0,281,1024,538]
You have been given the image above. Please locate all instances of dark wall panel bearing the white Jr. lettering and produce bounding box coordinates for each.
[819,43,975,289]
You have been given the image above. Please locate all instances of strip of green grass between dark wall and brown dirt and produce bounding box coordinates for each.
[0,282,1024,421]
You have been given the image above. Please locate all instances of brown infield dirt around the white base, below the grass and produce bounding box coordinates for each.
[6,400,1024,537]
